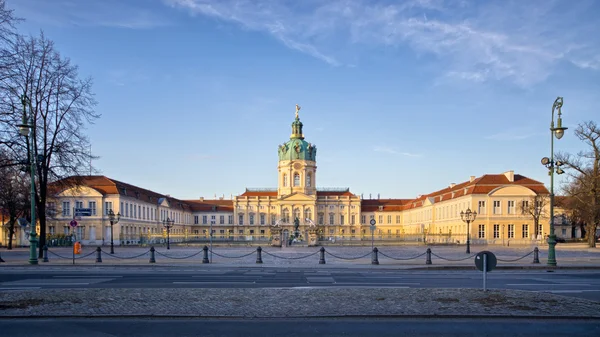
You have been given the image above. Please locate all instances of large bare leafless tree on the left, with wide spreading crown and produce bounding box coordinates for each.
[0,33,100,257]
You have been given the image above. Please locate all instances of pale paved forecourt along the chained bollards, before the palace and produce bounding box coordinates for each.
[0,244,600,268]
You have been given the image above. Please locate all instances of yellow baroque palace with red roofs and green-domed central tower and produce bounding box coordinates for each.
[38,106,559,245]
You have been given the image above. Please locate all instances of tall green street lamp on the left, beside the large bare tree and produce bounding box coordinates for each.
[18,95,38,264]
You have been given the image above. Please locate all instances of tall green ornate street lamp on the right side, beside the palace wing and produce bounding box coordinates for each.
[542,97,567,266]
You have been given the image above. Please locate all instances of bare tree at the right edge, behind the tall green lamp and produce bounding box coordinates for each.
[557,121,600,247]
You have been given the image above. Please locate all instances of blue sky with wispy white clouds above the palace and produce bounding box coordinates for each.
[7,0,600,199]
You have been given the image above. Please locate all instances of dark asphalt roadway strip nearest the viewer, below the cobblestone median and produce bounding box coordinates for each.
[0,318,600,337]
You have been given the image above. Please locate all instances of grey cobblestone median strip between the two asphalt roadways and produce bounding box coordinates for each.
[0,288,600,318]
